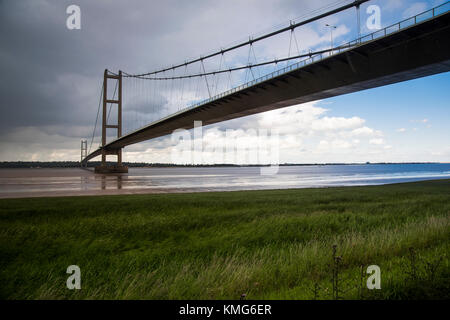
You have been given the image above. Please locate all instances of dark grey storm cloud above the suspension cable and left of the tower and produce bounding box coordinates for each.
[0,0,330,160]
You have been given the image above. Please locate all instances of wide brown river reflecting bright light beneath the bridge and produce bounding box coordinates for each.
[0,163,450,198]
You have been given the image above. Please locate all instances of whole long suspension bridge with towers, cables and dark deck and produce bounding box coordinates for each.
[81,0,450,173]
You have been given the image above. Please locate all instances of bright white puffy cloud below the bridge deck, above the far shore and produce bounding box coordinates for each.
[117,101,390,163]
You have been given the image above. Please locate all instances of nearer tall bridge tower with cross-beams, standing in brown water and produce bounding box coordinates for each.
[95,69,128,173]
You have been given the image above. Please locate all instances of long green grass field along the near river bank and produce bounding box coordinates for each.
[0,180,450,299]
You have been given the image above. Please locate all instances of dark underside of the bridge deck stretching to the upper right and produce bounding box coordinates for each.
[85,13,450,161]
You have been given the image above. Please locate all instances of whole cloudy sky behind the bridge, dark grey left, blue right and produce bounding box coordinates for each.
[0,0,450,163]
